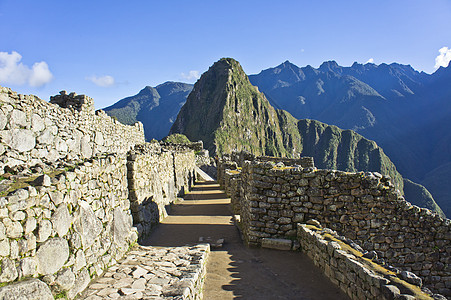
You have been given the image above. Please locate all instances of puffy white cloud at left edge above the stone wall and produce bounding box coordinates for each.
[0,51,53,87]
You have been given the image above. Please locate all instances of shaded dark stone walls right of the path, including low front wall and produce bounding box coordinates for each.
[218,152,451,299]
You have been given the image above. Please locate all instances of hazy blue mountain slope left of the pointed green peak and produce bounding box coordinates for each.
[103,81,193,141]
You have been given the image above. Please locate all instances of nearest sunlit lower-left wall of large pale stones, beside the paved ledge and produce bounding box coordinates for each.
[0,155,138,298]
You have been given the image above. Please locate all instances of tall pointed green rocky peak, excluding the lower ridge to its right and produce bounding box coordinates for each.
[169,59,294,156]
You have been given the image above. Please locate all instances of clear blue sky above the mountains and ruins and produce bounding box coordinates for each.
[0,0,451,108]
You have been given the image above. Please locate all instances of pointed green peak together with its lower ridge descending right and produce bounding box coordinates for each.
[169,58,443,214]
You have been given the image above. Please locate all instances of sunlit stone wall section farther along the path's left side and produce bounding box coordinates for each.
[127,142,195,238]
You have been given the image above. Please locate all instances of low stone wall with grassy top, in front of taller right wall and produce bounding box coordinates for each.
[297,224,438,300]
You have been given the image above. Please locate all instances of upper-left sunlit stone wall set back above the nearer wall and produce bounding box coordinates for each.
[0,87,145,174]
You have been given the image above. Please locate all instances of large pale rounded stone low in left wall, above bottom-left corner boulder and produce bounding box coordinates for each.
[36,238,69,275]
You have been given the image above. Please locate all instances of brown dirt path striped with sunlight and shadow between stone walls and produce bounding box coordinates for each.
[144,182,349,300]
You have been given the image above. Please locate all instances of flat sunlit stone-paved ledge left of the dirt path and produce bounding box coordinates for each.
[80,244,209,300]
